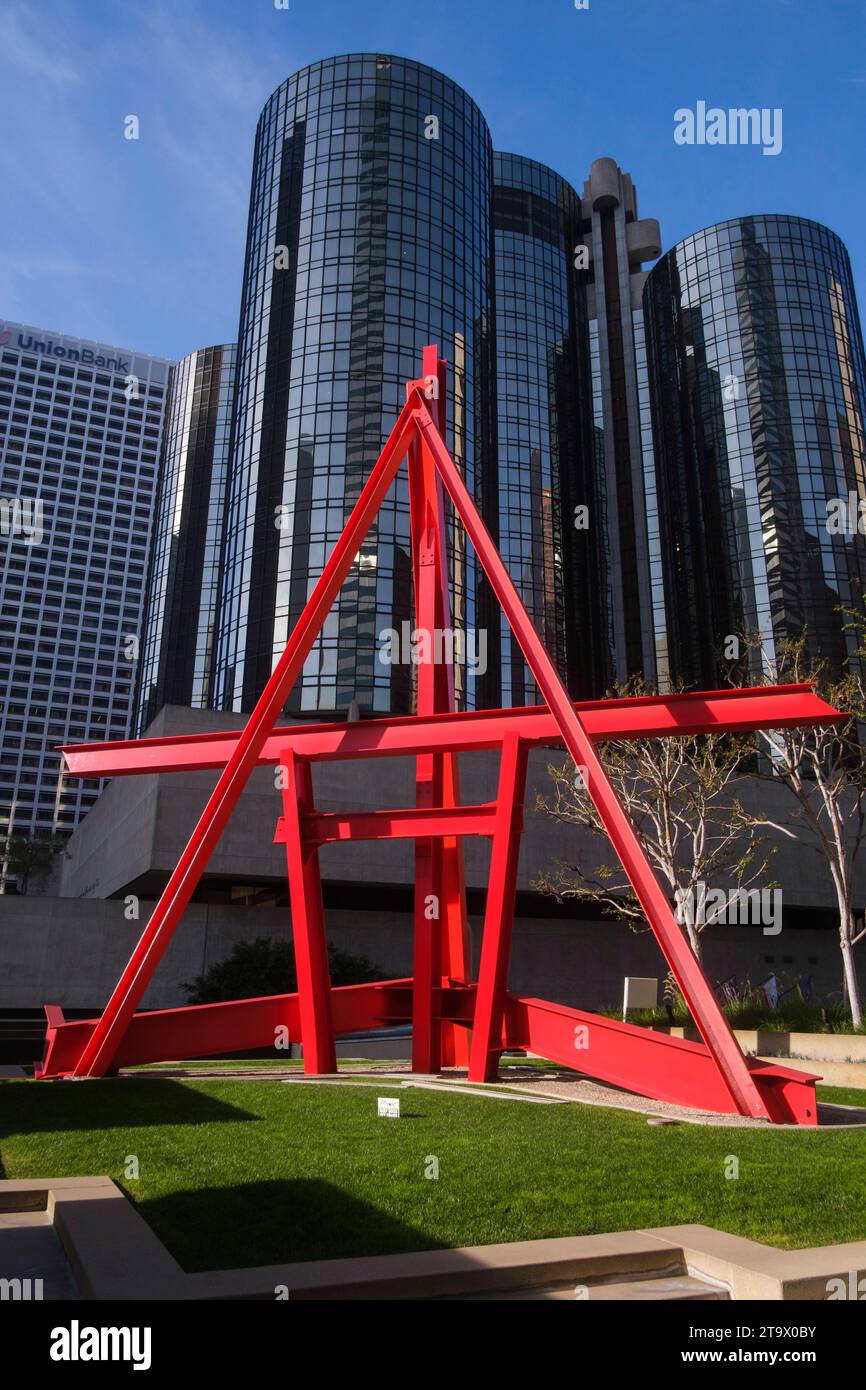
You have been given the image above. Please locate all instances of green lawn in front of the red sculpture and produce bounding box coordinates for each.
[0,1077,866,1270]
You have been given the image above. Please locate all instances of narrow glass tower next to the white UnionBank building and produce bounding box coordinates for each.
[136,343,235,734]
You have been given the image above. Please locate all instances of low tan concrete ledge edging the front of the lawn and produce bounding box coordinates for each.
[0,1177,866,1301]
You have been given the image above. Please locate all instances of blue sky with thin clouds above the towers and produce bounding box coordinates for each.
[0,0,866,357]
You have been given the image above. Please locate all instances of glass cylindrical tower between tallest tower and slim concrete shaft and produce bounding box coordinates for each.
[493,153,612,706]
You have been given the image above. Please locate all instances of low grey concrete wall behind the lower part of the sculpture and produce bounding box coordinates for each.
[0,897,866,1009]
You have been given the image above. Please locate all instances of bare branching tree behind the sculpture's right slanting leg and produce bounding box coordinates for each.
[534,681,774,959]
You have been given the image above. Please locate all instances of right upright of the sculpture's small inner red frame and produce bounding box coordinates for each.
[468,734,527,1081]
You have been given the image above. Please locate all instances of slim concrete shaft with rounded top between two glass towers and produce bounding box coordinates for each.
[582,158,667,694]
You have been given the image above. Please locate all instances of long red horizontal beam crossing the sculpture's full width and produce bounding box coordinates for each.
[60,685,848,777]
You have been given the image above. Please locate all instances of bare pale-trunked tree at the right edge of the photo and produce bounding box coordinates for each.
[742,625,866,1027]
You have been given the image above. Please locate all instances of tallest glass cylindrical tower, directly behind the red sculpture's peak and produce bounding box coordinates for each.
[214,54,495,719]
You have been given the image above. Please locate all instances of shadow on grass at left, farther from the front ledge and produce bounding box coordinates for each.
[0,1079,259,1140]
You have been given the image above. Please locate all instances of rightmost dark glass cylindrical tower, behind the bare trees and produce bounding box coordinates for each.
[645,215,866,687]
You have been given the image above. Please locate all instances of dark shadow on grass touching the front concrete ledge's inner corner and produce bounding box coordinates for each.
[136,1179,445,1273]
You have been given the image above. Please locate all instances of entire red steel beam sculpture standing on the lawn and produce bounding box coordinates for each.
[38,348,844,1125]
